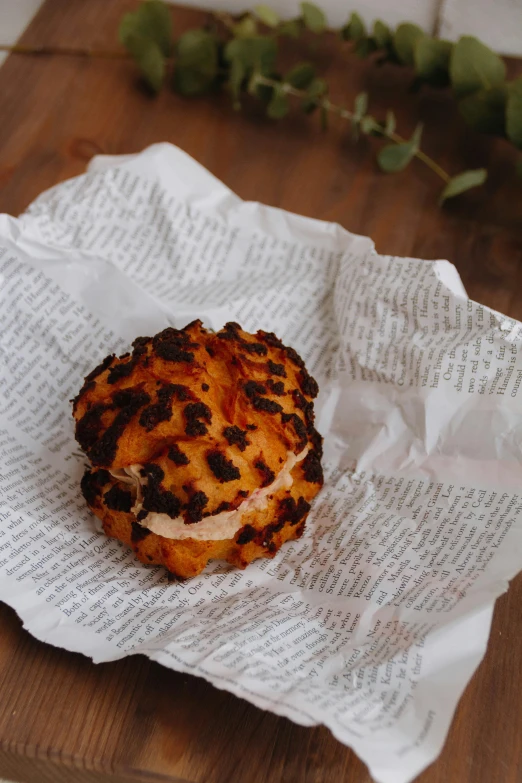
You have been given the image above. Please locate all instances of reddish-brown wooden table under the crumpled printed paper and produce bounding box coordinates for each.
[0,0,522,783]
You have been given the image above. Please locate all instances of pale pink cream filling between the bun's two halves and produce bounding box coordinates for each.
[110,445,310,541]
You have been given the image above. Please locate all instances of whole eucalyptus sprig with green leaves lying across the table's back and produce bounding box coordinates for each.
[4,0,522,202]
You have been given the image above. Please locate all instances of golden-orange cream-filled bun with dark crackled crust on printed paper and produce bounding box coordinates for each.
[73,321,323,578]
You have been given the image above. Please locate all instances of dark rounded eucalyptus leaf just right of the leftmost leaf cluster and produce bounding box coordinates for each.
[174,30,218,95]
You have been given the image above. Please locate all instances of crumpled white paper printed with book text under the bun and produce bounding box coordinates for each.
[0,144,522,783]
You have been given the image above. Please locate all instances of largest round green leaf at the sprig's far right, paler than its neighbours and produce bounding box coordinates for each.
[449,35,506,97]
